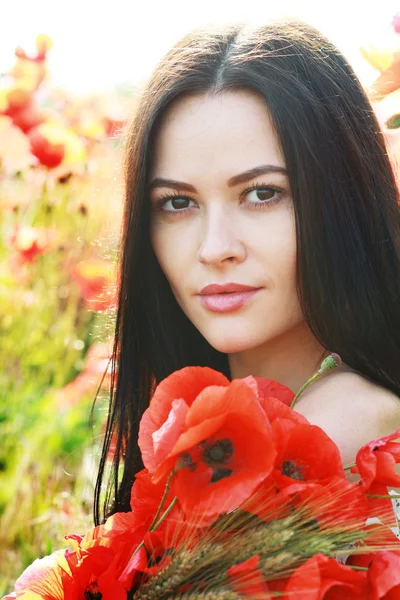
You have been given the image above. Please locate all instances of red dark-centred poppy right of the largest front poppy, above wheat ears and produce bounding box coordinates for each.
[245,418,367,526]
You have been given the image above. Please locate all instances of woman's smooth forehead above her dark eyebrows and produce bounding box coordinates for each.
[151,90,285,179]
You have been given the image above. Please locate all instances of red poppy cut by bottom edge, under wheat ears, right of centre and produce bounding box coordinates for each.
[284,554,372,600]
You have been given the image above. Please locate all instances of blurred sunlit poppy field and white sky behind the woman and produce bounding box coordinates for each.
[0,1,400,597]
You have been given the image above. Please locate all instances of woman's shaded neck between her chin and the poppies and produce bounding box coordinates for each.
[228,322,329,394]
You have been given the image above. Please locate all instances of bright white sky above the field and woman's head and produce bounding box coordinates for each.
[0,0,400,93]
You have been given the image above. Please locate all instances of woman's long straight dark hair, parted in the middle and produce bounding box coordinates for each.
[94,20,400,524]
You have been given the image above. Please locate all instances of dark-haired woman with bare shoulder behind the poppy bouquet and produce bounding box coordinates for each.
[95,20,400,523]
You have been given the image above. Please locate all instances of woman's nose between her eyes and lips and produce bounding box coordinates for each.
[197,207,247,266]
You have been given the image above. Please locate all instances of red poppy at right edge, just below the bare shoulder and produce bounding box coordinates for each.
[351,429,400,526]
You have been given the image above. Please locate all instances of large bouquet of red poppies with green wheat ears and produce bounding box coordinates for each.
[4,357,400,600]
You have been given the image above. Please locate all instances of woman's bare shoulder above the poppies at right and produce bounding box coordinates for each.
[296,368,400,463]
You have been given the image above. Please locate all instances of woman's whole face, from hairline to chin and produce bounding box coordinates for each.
[150,90,304,354]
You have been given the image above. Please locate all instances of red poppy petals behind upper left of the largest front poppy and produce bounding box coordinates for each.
[139,367,229,473]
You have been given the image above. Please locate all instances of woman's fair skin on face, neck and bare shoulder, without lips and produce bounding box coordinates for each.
[149,90,400,463]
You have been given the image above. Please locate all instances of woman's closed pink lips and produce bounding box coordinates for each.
[200,283,260,312]
